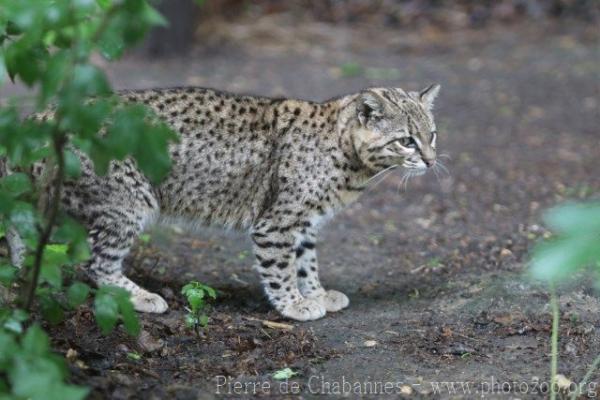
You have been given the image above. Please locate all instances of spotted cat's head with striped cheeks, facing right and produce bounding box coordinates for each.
[350,85,440,173]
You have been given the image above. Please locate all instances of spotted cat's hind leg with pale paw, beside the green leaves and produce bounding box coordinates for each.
[62,161,168,313]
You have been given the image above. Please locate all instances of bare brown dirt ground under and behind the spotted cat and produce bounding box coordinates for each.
[5,17,600,399]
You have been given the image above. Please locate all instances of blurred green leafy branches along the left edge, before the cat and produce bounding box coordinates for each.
[0,0,176,400]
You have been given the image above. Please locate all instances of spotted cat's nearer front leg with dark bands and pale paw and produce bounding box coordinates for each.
[251,219,326,321]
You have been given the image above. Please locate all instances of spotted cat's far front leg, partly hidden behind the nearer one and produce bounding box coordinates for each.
[296,229,350,311]
